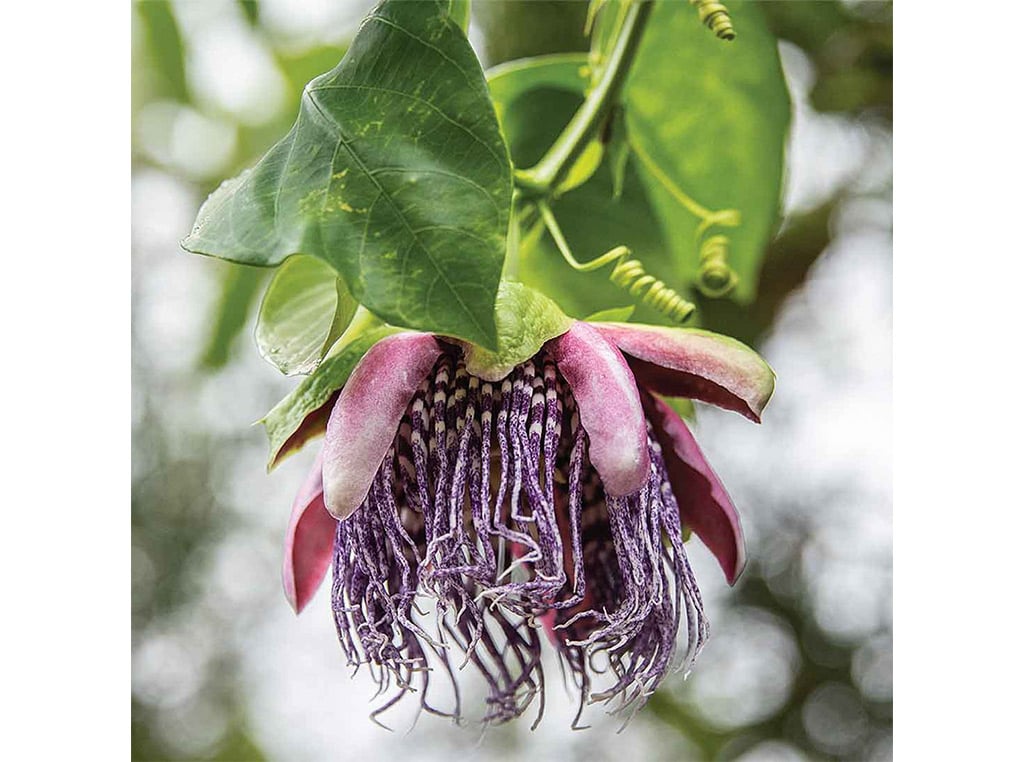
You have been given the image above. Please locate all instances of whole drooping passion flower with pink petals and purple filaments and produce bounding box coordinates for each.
[276,286,774,722]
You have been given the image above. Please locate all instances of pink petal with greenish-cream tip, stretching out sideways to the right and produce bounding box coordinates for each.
[593,323,775,423]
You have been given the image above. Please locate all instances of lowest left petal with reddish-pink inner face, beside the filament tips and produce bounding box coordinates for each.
[283,455,338,613]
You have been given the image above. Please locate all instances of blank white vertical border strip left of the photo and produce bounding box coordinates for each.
[0,2,131,759]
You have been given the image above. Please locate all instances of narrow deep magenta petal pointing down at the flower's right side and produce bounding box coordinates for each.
[644,394,746,585]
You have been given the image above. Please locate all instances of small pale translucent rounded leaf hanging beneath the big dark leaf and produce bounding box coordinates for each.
[255,255,356,376]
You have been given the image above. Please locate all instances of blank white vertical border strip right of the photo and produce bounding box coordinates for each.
[894,1,1024,760]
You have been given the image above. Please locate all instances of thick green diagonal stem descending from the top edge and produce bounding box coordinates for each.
[515,0,653,197]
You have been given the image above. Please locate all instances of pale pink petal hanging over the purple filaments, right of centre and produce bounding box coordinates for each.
[547,323,650,497]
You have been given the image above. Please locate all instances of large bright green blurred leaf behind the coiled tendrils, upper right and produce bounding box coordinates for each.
[626,0,790,303]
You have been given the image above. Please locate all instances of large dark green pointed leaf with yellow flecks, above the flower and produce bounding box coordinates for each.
[182,0,512,348]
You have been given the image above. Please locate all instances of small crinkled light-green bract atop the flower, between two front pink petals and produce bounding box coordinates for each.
[463,281,572,381]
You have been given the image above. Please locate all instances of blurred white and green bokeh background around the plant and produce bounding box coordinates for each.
[131,0,892,761]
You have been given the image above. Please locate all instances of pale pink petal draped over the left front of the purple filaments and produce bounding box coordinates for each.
[324,332,441,519]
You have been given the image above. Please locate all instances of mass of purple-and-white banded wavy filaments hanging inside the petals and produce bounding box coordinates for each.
[332,351,708,722]
